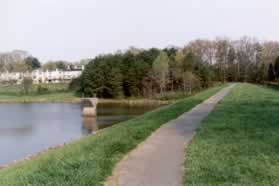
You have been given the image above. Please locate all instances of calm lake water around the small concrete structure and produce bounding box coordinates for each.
[0,103,158,165]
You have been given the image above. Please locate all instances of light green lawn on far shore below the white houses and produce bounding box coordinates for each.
[0,84,79,103]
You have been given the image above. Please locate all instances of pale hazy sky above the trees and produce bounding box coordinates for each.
[0,0,279,62]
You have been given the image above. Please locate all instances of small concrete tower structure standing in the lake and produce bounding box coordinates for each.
[81,98,98,117]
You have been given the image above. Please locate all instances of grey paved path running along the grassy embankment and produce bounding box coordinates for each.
[105,85,233,186]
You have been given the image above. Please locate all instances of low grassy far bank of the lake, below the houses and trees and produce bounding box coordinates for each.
[0,83,191,106]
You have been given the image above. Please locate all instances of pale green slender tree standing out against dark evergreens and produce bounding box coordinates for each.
[152,51,169,93]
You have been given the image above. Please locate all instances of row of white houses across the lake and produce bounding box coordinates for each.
[0,65,84,84]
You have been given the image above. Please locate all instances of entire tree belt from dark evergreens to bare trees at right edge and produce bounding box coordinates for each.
[75,37,279,97]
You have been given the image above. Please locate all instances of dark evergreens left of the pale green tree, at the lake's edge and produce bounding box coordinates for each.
[76,48,160,97]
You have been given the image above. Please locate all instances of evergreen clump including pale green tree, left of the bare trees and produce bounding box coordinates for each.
[72,48,213,97]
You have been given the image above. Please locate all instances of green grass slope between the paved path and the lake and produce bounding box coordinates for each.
[0,86,225,186]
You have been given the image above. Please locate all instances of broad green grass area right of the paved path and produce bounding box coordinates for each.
[184,84,279,185]
